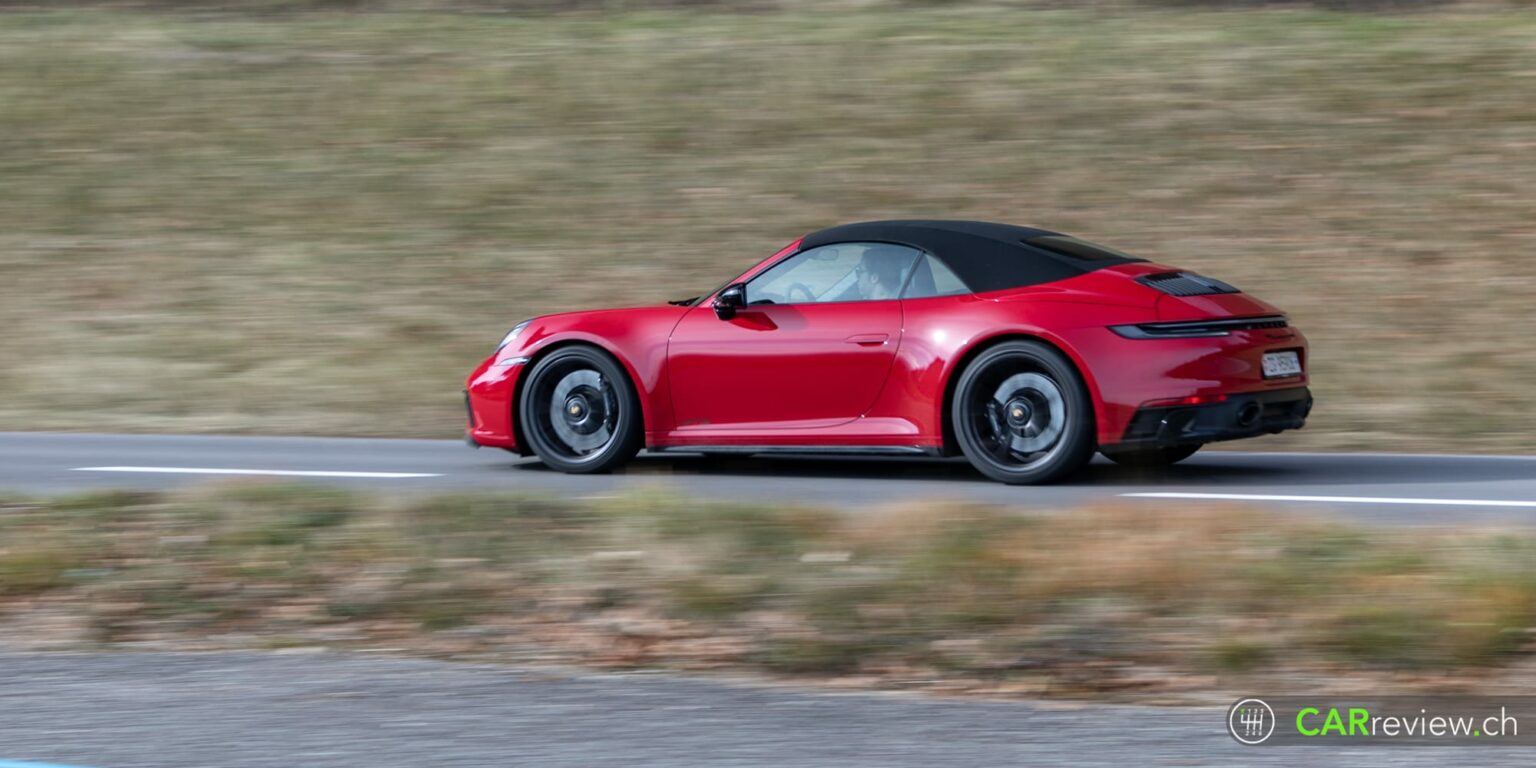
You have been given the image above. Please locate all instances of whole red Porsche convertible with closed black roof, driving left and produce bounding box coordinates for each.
[465,221,1312,482]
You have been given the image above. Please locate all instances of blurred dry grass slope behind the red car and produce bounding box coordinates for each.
[0,3,1536,452]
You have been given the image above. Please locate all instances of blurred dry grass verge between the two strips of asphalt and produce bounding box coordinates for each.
[9,484,1536,700]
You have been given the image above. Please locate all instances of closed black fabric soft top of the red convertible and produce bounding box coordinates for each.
[800,220,1144,293]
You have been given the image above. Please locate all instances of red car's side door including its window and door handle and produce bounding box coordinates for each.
[667,243,920,432]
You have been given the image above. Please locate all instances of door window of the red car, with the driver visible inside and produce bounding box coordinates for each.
[746,243,922,304]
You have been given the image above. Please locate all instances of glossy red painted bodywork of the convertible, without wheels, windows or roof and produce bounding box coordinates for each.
[467,233,1307,452]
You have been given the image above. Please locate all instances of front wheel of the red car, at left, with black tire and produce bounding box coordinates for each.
[518,346,645,475]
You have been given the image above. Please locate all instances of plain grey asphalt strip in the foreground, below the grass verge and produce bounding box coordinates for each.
[0,653,1531,768]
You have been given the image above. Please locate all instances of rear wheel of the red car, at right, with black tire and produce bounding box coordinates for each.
[949,341,1094,485]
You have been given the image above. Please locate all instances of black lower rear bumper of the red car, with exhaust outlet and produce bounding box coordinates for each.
[1117,387,1312,449]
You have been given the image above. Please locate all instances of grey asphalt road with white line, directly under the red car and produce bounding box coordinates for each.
[0,433,1536,525]
